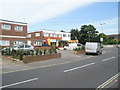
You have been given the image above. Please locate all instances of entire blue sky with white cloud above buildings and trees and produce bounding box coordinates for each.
[0,0,119,35]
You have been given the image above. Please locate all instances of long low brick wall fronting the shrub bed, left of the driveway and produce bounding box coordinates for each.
[23,53,61,63]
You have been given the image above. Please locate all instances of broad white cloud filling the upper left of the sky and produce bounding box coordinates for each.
[0,0,100,24]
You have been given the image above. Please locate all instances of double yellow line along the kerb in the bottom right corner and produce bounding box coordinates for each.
[96,72,120,90]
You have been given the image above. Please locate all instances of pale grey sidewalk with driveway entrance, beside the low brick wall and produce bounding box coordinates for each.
[2,50,90,73]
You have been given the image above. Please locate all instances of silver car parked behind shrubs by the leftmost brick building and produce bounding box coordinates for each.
[2,44,34,52]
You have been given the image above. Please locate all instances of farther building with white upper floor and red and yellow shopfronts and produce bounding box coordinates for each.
[28,30,71,47]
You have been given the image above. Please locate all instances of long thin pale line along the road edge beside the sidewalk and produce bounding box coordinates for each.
[0,57,90,74]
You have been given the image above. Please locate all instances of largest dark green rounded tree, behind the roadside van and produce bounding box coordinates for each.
[79,25,99,44]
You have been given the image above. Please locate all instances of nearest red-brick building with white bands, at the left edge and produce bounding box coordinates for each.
[0,19,27,47]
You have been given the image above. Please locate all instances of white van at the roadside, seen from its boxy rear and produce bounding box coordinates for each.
[85,42,103,55]
